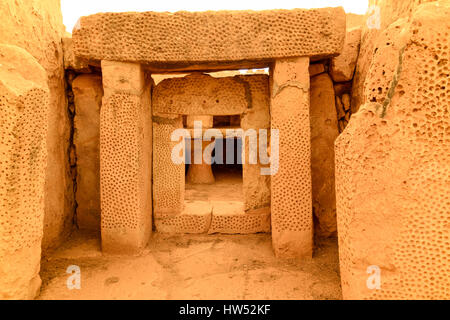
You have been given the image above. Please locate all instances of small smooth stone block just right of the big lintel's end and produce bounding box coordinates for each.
[330,28,361,82]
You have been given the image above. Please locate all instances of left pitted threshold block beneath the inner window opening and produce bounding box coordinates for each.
[155,201,212,234]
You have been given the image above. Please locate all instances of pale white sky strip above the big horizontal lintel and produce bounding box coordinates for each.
[61,0,368,32]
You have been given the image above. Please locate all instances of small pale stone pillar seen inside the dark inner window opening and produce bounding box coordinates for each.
[187,116,215,184]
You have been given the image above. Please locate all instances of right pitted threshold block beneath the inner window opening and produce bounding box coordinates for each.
[208,201,270,234]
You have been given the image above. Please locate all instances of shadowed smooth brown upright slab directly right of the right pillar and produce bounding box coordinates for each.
[310,73,339,237]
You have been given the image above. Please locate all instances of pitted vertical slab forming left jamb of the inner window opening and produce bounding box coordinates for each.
[153,115,185,218]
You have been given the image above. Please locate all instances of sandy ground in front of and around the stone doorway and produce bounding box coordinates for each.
[38,233,341,300]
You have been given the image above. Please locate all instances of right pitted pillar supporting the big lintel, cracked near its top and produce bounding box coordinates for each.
[271,58,313,258]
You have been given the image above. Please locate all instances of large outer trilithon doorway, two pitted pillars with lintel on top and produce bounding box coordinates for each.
[73,8,346,258]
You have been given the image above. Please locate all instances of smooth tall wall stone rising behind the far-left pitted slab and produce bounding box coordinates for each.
[0,0,74,249]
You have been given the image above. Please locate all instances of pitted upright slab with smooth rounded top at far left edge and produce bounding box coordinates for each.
[0,44,49,300]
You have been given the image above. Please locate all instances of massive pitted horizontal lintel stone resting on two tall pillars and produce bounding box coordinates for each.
[73,7,345,66]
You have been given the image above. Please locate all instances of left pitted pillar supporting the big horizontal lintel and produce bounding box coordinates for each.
[100,61,152,253]
